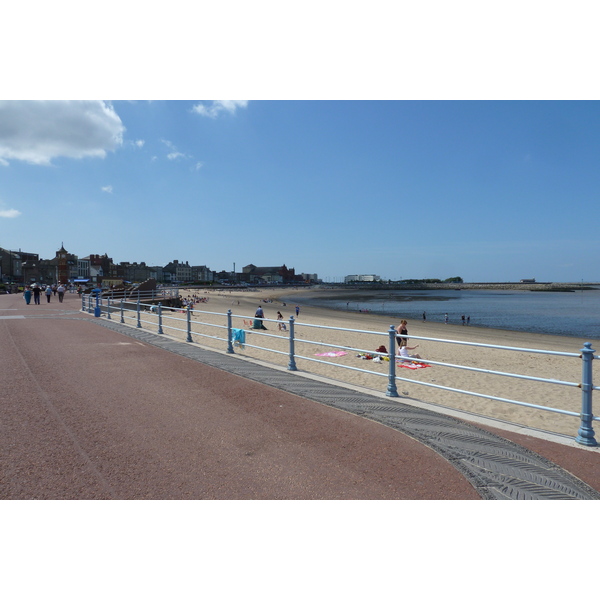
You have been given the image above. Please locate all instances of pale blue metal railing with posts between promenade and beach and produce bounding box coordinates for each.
[82,293,600,446]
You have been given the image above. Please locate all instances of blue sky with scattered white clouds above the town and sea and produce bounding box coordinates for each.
[0,100,600,281]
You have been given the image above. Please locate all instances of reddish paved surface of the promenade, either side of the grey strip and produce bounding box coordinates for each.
[0,294,600,499]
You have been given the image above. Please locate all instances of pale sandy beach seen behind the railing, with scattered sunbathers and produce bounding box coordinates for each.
[127,289,597,436]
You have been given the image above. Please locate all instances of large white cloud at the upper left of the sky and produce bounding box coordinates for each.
[0,100,125,165]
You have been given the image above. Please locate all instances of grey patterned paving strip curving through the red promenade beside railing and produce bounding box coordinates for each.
[95,319,600,500]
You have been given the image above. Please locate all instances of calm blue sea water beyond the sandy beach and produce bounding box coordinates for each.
[285,290,600,340]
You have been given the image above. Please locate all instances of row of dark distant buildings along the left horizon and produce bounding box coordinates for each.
[0,244,318,287]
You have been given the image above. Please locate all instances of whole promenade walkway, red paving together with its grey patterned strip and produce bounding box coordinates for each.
[0,294,600,500]
